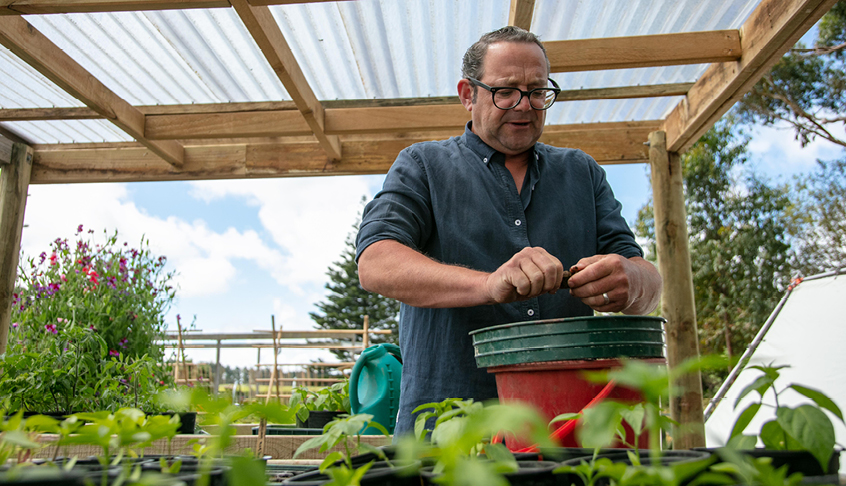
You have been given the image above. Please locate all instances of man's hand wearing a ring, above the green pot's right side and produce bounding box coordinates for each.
[567,255,662,314]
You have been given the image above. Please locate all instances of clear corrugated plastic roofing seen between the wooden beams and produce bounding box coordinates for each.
[0,0,759,143]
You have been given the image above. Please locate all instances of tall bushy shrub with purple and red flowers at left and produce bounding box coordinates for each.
[9,225,174,361]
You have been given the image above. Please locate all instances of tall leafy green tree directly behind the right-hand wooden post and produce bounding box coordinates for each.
[636,119,794,389]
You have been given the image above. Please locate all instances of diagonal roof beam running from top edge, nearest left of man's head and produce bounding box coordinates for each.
[231,0,341,161]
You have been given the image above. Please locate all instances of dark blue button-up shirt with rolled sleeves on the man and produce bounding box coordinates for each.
[356,124,643,435]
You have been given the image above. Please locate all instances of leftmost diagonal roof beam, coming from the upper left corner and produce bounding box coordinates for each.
[0,16,183,167]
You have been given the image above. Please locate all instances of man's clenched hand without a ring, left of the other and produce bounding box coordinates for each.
[485,247,564,304]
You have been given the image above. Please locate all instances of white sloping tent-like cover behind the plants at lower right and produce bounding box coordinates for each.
[705,272,846,474]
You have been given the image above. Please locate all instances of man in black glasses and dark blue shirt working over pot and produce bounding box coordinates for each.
[356,27,661,435]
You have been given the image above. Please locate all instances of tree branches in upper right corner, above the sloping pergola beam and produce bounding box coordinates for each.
[738,1,846,147]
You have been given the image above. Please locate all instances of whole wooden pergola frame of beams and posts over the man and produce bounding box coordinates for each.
[0,0,835,448]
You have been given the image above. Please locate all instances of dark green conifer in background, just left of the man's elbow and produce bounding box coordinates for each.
[309,218,399,361]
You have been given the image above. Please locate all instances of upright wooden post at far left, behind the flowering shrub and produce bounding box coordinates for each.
[0,139,32,355]
